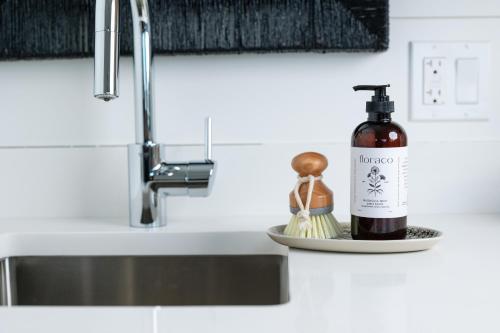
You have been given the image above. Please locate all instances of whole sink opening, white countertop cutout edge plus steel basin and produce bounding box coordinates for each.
[0,233,288,306]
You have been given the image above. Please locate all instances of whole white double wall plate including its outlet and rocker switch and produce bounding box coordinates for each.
[410,42,490,120]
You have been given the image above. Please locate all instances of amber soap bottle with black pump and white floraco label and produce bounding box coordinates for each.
[351,84,408,240]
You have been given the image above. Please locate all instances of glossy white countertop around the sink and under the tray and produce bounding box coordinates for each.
[0,215,500,333]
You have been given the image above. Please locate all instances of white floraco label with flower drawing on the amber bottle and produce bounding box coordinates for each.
[351,147,408,218]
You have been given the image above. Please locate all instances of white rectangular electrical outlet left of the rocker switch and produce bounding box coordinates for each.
[423,58,446,105]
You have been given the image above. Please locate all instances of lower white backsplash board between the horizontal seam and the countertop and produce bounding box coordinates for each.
[0,142,500,219]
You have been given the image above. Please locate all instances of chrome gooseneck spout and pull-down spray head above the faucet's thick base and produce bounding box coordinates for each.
[94,0,155,145]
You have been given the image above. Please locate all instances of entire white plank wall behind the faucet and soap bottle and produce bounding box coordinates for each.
[0,0,500,218]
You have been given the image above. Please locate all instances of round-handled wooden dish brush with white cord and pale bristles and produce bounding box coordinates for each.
[283,152,342,239]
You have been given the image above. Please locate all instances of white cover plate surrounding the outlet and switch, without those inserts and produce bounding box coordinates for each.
[410,41,490,120]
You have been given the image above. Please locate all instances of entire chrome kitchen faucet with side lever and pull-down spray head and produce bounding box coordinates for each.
[94,0,215,227]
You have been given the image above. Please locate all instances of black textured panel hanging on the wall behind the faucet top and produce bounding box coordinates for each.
[0,0,389,59]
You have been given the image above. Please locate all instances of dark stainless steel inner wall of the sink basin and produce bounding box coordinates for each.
[0,255,288,305]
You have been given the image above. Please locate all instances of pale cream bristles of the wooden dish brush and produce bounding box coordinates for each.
[283,213,342,239]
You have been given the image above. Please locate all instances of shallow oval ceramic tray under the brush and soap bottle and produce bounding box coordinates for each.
[267,223,443,253]
